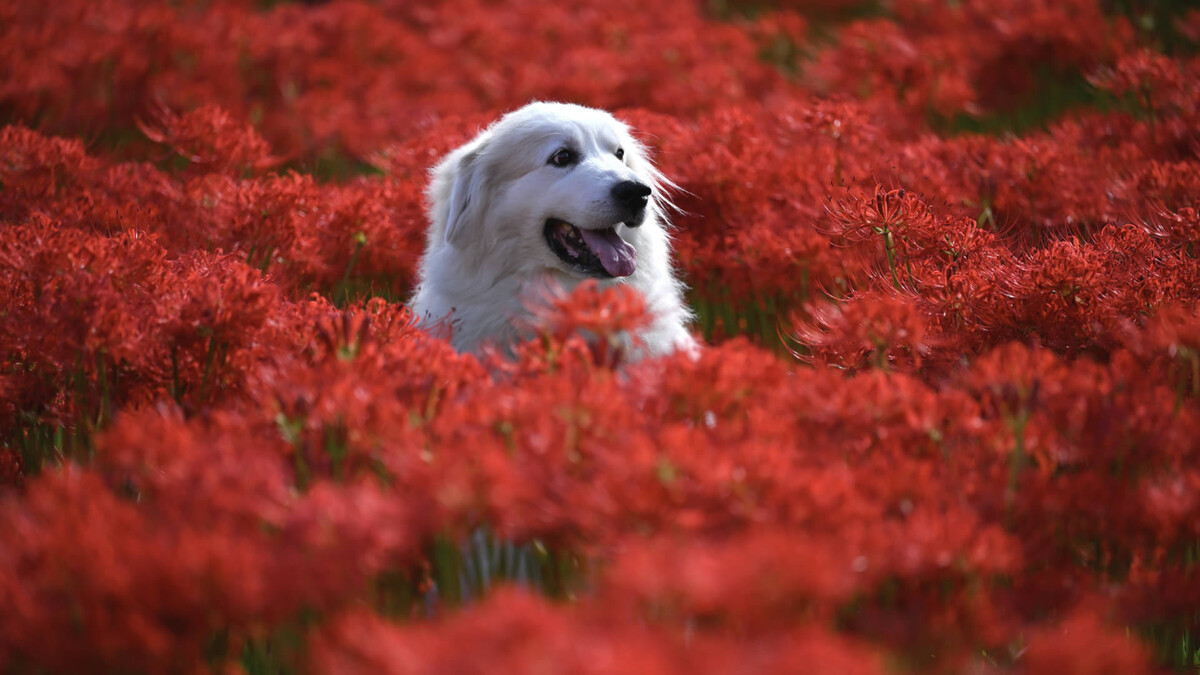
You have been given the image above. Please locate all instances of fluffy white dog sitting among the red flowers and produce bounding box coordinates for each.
[412,102,697,357]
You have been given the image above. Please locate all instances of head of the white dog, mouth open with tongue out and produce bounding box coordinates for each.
[430,102,667,279]
